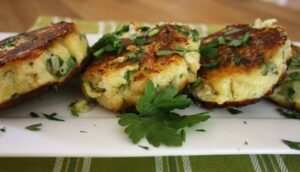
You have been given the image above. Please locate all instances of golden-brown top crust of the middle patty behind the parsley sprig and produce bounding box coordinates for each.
[84,24,187,81]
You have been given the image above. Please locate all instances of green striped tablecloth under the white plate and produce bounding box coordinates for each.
[0,17,300,172]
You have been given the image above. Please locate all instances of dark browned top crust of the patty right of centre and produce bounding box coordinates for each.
[199,24,287,79]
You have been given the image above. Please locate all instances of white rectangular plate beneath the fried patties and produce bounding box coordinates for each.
[0,33,300,157]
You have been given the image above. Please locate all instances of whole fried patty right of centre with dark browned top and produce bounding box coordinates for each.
[191,21,292,107]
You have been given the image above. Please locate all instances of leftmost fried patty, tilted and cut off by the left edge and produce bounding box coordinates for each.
[0,22,88,109]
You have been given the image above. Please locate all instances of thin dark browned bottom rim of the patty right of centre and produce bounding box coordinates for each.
[193,73,286,109]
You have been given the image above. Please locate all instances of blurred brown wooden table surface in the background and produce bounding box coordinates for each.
[0,0,300,41]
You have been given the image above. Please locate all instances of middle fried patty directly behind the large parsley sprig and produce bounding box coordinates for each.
[82,24,200,111]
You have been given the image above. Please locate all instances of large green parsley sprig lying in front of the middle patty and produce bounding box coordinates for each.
[119,80,209,147]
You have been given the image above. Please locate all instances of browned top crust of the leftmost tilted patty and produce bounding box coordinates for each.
[0,22,78,67]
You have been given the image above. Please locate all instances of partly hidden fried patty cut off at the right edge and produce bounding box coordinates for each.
[268,46,300,112]
